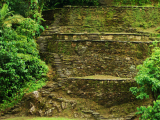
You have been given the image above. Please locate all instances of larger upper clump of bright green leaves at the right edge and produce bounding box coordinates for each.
[130,47,160,100]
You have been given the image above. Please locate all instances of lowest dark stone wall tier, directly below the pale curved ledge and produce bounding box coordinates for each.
[66,78,137,107]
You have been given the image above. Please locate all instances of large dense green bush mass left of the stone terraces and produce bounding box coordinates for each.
[0,2,48,102]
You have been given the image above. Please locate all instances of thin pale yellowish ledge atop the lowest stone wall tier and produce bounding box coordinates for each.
[68,75,134,81]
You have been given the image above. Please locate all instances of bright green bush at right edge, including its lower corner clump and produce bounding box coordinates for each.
[130,44,160,120]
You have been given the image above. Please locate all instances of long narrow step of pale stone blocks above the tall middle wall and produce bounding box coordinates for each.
[37,31,152,43]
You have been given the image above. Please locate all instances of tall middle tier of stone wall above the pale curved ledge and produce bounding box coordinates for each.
[43,41,151,78]
